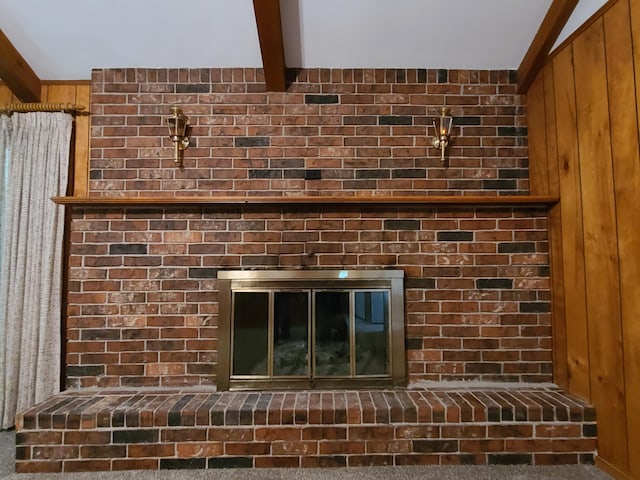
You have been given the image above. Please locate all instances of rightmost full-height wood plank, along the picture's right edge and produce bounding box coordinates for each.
[604,1,640,478]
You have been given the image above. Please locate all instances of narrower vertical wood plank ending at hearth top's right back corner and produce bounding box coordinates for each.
[552,48,591,399]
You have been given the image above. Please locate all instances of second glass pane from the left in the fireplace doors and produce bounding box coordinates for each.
[273,292,309,376]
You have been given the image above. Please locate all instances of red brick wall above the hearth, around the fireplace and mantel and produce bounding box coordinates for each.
[66,69,551,387]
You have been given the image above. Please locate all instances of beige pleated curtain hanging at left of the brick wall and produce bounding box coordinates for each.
[0,112,72,428]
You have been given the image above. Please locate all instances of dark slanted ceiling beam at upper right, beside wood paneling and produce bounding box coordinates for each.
[518,0,578,94]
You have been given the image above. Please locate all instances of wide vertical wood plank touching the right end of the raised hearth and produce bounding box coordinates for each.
[573,15,628,470]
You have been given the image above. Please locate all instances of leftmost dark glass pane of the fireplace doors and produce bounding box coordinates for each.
[233,292,269,375]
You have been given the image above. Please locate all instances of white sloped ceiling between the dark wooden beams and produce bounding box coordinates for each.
[0,0,606,80]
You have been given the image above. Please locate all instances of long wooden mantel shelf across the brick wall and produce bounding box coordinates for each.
[52,195,559,208]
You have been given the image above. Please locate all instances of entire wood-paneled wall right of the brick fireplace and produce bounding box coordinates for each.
[527,0,640,479]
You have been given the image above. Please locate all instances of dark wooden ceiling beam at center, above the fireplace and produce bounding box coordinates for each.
[253,0,287,92]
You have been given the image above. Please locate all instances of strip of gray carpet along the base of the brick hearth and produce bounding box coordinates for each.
[0,432,612,480]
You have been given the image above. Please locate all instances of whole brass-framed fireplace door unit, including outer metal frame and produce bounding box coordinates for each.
[218,270,405,390]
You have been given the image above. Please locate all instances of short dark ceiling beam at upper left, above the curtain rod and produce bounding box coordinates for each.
[0,30,40,102]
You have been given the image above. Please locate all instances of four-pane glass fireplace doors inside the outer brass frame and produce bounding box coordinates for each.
[231,290,390,380]
